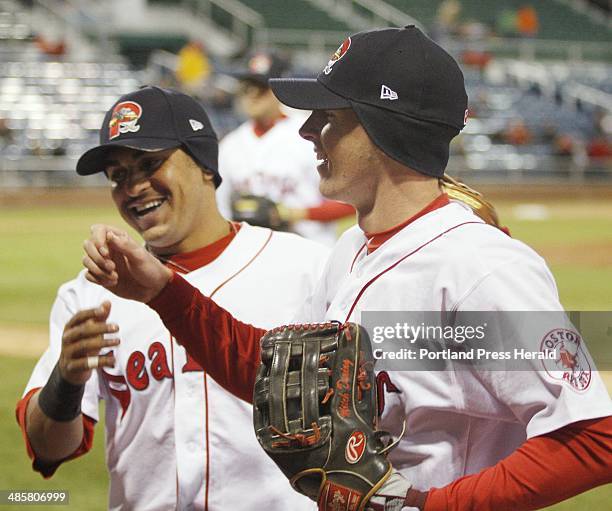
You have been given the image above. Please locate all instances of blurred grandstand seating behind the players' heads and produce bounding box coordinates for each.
[0,0,612,187]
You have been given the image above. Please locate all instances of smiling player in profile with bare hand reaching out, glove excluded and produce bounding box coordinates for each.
[86,26,612,511]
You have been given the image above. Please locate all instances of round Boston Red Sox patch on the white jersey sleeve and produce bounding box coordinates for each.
[540,328,591,391]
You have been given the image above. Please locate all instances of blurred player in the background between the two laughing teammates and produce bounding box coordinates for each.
[219,52,355,246]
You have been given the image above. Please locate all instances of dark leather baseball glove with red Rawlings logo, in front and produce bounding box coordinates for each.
[253,323,393,511]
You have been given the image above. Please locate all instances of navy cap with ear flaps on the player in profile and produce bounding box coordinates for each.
[270,25,467,177]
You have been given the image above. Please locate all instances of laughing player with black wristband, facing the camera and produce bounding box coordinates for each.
[17,87,327,511]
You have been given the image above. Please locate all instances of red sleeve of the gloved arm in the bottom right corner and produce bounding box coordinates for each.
[425,417,612,511]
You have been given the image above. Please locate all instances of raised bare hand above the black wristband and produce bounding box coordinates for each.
[59,302,119,385]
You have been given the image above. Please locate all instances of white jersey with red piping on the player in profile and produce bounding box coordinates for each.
[297,202,612,490]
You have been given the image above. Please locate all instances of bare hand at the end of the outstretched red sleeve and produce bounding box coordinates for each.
[83,224,172,303]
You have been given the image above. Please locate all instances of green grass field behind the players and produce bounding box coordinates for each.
[0,195,612,511]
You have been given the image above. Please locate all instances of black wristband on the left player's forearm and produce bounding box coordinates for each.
[38,363,85,422]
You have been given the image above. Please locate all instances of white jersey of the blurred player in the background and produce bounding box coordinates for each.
[217,117,336,246]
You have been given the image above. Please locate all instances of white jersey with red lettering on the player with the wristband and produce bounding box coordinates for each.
[26,224,327,511]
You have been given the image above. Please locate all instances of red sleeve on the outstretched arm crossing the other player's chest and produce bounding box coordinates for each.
[148,273,266,403]
